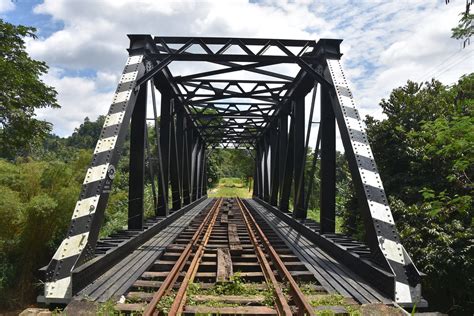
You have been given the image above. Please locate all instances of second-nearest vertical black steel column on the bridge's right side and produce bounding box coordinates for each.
[293,96,307,219]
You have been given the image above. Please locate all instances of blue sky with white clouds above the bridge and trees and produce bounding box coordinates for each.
[0,0,474,141]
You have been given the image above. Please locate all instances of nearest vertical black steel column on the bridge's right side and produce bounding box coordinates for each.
[320,87,336,233]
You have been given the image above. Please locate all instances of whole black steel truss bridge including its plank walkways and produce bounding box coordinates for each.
[38,35,426,311]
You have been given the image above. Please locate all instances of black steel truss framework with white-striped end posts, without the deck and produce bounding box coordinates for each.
[40,35,420,304]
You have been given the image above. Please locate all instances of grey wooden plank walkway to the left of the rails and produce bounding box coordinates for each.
[75,199,211,302]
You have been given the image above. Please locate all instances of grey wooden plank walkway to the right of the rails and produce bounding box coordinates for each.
[247,200,391,304]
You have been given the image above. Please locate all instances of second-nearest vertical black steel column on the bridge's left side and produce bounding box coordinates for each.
[169,99,181,211]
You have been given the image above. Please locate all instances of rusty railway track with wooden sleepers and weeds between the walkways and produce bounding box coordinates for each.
[115,198,356,315]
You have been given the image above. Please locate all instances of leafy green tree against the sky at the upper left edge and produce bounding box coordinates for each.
[0,19,59,159]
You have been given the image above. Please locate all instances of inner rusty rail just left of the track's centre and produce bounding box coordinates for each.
[168,198,222,315]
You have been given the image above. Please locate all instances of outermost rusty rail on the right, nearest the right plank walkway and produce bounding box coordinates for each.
[237,198,315,315]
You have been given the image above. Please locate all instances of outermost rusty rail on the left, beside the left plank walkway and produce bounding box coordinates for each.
[143,198,222,316]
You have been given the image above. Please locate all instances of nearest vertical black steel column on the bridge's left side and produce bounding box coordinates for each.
[128,81,147,229]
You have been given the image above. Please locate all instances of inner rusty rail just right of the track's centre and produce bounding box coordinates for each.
[236,198,293,315]
